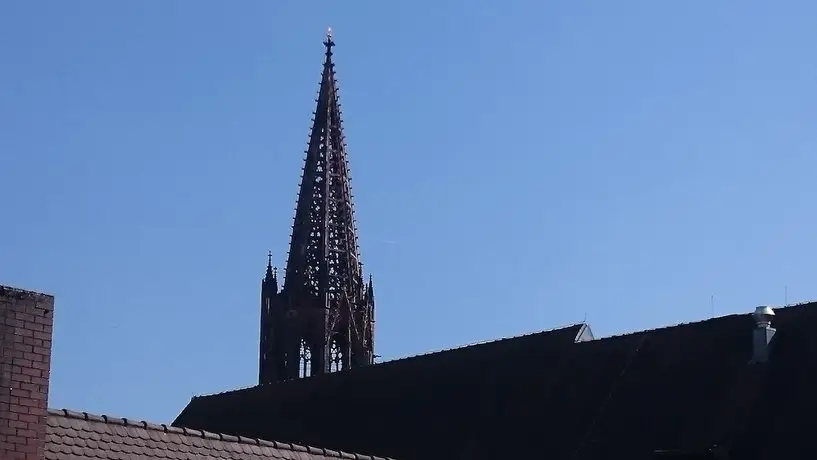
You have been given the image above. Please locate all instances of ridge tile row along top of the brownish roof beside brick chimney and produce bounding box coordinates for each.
[48,409,394,460]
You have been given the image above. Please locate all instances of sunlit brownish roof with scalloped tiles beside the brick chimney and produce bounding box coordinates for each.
[45,409,396,460]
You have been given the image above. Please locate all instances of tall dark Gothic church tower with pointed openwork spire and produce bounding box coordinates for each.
[259,31,374,384]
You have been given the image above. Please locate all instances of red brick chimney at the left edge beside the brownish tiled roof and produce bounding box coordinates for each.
[0,286,54,460]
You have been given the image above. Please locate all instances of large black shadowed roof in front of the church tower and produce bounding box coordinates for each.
[174,304,817,460]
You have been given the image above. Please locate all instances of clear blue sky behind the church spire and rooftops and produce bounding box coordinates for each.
[0,0,817,422]
